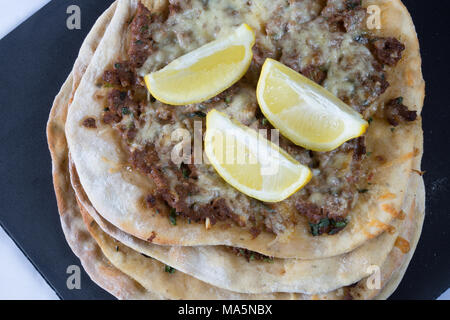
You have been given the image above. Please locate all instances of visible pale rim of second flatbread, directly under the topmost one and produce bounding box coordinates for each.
[69,156,417,294]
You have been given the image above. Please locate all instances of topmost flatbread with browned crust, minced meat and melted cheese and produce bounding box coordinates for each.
[66,1,424,259]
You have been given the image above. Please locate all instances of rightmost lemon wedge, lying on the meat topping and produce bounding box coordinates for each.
[257,59,369,151]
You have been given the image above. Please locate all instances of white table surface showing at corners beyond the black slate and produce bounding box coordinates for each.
[0,0,450,300]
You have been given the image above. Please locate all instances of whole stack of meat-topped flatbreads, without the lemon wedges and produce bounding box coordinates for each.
[48,0,424,299]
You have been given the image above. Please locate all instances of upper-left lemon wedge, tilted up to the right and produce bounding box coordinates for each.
[144,24,255,105]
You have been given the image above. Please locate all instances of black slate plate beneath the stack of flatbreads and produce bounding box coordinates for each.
[0,0,450,299]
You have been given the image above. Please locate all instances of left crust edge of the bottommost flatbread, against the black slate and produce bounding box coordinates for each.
[47,3,159,299]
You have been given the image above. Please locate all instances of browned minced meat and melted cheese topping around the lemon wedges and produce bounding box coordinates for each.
[96,0,413,237]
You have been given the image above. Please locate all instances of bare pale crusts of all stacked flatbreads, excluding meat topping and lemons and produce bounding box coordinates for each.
[47,0,425,299]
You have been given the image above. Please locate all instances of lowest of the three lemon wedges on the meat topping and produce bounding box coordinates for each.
[205,110,312,202]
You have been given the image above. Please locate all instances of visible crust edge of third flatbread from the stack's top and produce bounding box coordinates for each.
[77,170,424,300]
